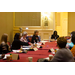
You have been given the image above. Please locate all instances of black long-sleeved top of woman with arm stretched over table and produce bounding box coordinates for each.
[11,39,29,50]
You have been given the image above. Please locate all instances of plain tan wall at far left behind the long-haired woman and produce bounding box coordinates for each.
[0,12,13,42]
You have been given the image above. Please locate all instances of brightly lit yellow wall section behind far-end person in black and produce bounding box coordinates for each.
[55,12,68,36]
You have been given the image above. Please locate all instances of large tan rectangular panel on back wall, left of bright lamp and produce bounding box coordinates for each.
[15,12,41,26]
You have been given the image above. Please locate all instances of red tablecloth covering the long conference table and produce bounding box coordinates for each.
[0,42,57,62]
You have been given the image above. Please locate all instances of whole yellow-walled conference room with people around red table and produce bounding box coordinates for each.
[0,12,75,62]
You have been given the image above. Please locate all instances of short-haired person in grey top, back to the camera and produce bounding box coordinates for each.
[50,37,74,62]
